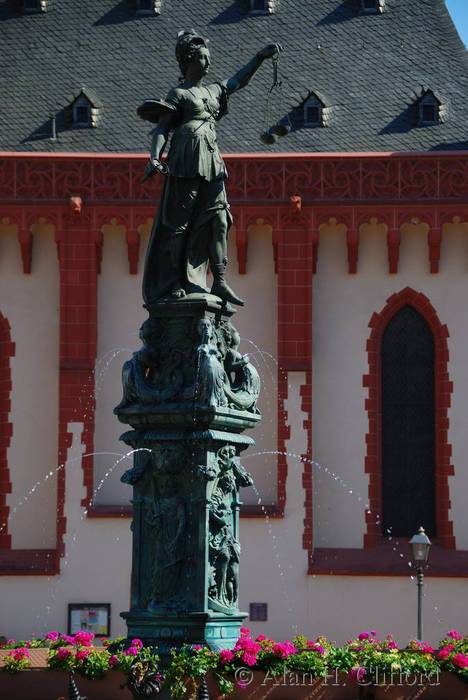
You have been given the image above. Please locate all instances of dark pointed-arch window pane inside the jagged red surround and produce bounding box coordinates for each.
[381,305,436,537]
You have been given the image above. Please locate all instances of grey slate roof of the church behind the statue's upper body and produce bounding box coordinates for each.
[0,0,468,153]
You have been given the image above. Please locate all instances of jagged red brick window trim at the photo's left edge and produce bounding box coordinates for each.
[0,313,15,549]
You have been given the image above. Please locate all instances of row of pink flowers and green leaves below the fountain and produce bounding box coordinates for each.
[0,628,468,700]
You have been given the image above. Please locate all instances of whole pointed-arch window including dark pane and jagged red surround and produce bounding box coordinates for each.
[364,287,455,549]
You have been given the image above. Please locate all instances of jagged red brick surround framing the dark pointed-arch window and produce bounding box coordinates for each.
[363,287,455,549]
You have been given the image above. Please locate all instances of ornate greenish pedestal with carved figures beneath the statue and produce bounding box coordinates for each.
[115,297,260,654]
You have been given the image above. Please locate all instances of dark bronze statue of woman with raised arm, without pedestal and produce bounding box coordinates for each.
[138,30,281,306]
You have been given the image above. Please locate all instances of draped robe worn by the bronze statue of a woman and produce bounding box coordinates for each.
[143,83,232,305]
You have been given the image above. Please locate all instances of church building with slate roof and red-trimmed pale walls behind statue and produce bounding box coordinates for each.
[0,0,468,642]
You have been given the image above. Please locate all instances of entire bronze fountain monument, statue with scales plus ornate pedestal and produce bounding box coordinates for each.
[114,30,282,656]
